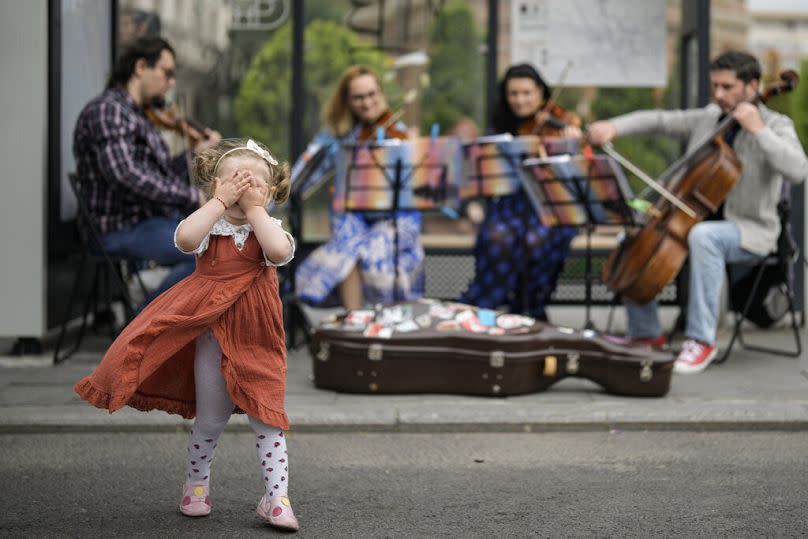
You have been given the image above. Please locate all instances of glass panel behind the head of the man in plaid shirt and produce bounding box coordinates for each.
[118,0,292,219]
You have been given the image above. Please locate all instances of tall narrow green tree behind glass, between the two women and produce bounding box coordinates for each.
[421,1,484,133]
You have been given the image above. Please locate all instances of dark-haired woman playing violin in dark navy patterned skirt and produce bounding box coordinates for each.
[460,64,581,320]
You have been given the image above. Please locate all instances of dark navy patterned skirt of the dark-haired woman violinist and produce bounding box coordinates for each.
[460,191,576,318]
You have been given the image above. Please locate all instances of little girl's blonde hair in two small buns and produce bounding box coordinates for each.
[193,138,292,204]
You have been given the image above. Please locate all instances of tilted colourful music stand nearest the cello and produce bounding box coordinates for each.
[522,155,638,329]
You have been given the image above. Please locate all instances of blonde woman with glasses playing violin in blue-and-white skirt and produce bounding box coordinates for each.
[292,65,424,309]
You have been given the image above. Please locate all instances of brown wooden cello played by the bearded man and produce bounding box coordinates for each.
[601,70,799,303]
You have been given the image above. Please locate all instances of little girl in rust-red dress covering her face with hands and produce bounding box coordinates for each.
[75,139,298,530]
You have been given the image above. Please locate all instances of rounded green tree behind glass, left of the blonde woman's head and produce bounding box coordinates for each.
[235,20,399,161]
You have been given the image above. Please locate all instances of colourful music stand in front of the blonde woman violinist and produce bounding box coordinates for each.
[332,137,462,301]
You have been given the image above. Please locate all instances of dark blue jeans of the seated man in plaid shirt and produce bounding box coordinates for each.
[101,217,196,311]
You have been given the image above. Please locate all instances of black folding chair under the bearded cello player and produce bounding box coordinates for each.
[716,192,802,363]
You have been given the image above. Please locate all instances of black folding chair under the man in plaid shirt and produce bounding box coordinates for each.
[53,174,148,363]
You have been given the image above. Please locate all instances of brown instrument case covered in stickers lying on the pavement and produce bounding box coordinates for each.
[310,299,674,397]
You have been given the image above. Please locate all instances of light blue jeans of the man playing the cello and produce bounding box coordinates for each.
[625,221,764,344]
